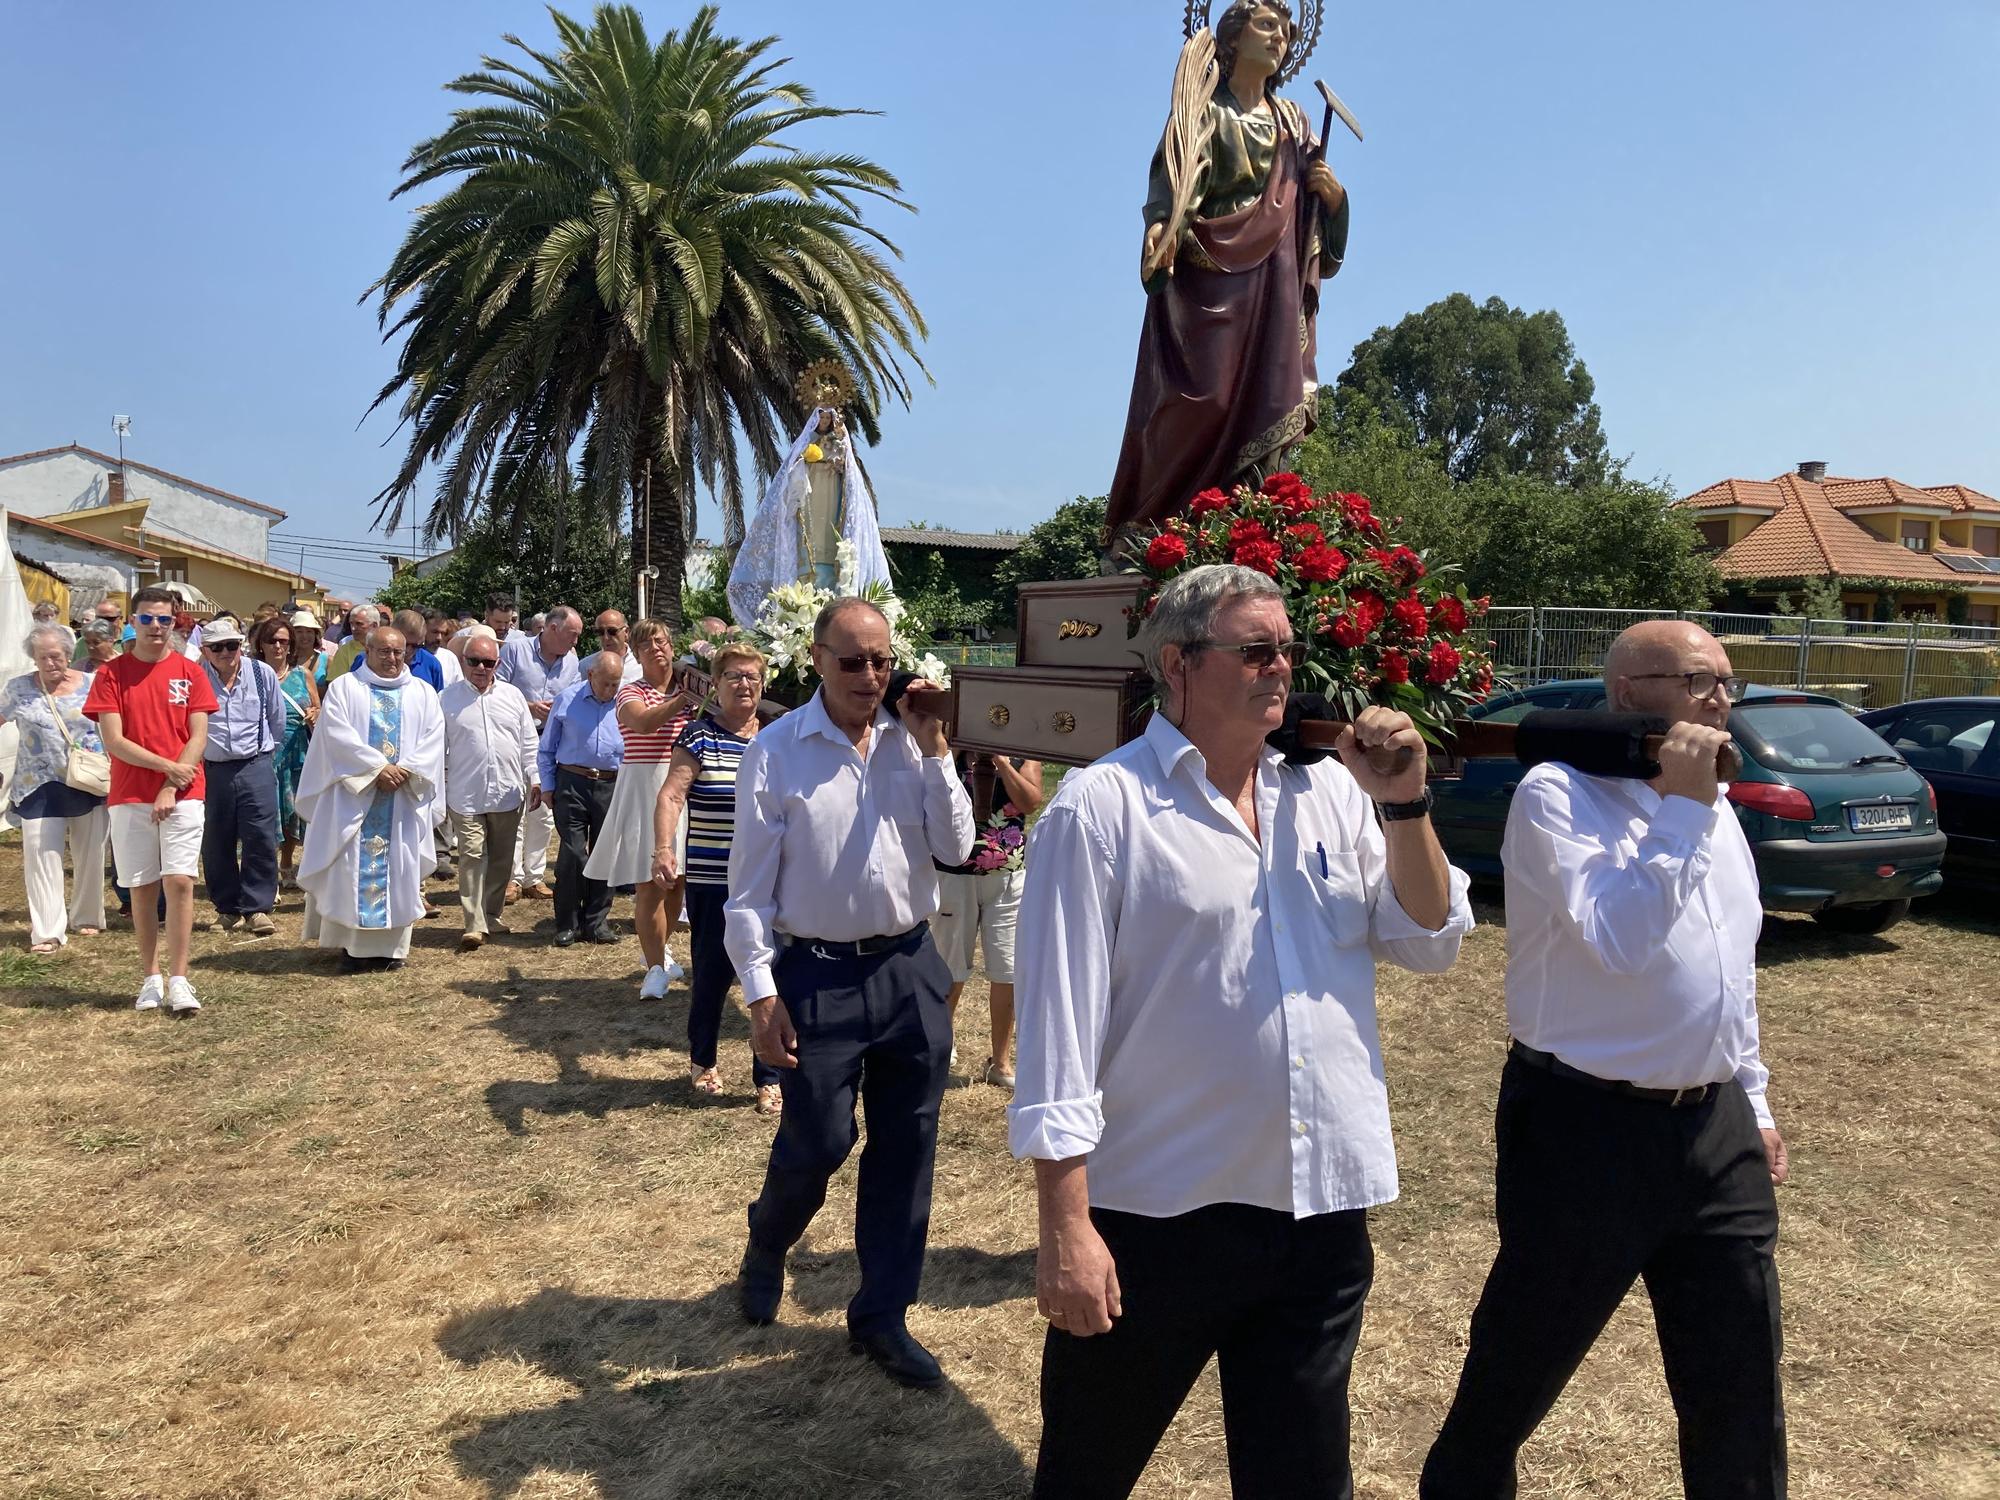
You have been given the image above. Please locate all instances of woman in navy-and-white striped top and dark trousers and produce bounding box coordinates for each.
[654,644,784,1114]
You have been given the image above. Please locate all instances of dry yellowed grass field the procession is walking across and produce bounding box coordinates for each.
[0,848,2000,1500]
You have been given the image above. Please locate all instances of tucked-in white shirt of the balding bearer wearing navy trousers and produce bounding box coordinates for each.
[724,694,974,1002]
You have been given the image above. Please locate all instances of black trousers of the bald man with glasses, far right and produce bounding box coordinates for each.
[1420,1058,1786,1500]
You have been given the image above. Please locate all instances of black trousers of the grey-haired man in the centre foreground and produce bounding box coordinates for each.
[1034,1204,1374,1500]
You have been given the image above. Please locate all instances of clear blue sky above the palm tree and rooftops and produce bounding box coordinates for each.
[0,0,2000,600]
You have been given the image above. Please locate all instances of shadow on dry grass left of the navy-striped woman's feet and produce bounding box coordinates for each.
[454,968,754,1136]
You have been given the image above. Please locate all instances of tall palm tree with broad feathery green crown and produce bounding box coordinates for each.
[364,4,928,624]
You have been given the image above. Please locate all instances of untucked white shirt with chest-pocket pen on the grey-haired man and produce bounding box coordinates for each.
[1008,714,1472,1218]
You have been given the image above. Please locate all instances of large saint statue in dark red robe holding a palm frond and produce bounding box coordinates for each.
[1108,0,1348,538]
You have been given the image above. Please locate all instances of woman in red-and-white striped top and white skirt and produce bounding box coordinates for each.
[584,620,700,1000]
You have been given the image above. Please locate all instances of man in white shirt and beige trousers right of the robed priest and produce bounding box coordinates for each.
[438,626,540,952]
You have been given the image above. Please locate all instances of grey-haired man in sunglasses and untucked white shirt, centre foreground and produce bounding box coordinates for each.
[1008,566,1472,1500]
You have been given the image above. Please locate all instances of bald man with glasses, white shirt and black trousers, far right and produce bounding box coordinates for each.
[1420,620,1786,1500]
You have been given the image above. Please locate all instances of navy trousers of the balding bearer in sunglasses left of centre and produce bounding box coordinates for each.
[750,928,952,1334]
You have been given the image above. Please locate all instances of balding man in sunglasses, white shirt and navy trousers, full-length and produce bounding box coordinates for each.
[724,598,974,1386]
